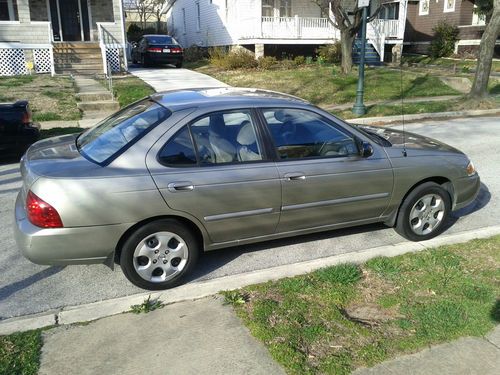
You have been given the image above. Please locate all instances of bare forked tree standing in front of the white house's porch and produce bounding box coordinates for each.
[311,0,380,74]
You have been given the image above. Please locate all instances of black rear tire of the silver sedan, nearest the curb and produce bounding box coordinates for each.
[120,219,200,290]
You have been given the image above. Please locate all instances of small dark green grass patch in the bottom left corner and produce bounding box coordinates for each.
[0,330,42,375]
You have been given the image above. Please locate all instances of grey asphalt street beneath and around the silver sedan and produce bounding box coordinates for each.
[0,117,500,319]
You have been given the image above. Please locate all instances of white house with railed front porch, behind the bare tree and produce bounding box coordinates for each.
[164,0,408,60]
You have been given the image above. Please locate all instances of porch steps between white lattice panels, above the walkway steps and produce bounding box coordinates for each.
[54,42,104,75]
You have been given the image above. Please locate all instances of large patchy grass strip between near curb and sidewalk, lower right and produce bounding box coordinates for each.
[225,236,500,374]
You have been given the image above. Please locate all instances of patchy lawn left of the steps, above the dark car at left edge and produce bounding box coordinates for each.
[0,75,81,121]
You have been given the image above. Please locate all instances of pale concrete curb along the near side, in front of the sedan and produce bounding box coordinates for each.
[0,225,500,335]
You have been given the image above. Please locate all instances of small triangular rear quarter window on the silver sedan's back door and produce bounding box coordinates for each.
[159,126,197,167]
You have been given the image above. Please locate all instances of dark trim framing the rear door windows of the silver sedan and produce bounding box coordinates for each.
[156,107,274,169]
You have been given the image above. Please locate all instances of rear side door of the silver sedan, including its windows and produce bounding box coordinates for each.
[147,109,281,247]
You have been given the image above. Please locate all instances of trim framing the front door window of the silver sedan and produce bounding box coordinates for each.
[258,106,360,162]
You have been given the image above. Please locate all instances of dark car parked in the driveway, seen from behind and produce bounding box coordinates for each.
[132,35,184,68]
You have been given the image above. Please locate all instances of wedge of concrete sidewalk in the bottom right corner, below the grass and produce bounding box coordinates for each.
[353,326,500,375]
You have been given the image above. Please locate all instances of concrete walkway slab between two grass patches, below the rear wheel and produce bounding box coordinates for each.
[39,298,284,375]
